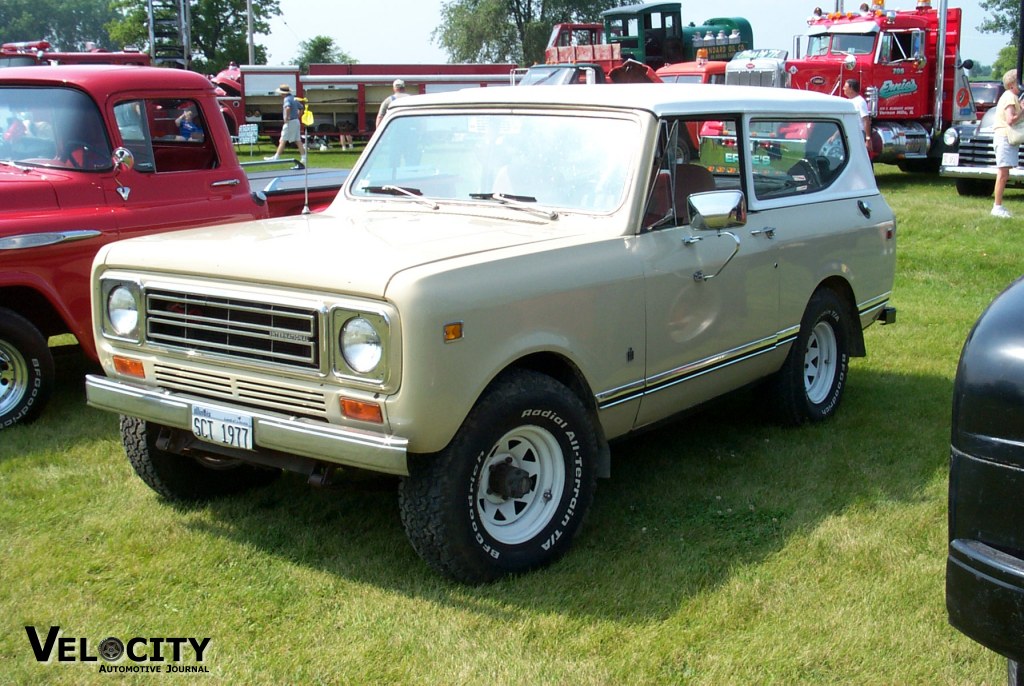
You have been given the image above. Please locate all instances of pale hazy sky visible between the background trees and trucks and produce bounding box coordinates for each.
[256,0,1010,65]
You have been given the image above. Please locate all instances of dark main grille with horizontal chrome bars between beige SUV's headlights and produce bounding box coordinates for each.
[145,290,319,370]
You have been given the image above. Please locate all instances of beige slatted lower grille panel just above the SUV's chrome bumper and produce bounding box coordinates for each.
[154,363,327,419]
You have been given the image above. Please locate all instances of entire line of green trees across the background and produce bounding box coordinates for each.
[0,0,1020,75]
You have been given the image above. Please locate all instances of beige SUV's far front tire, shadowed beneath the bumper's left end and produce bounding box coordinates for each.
[121,415,281,501]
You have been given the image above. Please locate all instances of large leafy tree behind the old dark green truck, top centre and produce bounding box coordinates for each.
[432,0,630,65]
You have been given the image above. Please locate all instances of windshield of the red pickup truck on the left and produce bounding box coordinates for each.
[0,87,112,171]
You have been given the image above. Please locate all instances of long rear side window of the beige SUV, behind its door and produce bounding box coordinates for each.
[750,120,849,200]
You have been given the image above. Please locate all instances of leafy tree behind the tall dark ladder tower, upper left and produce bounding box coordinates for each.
[106,0,281,72]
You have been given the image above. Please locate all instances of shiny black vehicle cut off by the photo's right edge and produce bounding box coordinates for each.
[946,280,1024,685]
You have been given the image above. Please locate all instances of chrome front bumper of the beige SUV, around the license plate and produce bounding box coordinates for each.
[85,375,409,476]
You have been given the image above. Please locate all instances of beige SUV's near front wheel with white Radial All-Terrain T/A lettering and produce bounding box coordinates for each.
[399,371,597,584]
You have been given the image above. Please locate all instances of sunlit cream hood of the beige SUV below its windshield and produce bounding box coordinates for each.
[96,207,580,298]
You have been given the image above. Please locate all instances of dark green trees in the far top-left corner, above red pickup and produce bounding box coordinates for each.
[0,0,118,51]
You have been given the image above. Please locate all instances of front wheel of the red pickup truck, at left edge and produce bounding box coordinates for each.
[0,307,53,429]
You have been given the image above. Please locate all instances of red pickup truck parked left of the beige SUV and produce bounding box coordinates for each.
[0,66,345,429]
